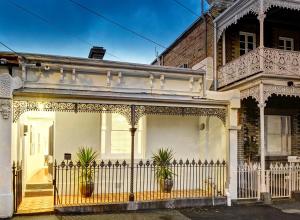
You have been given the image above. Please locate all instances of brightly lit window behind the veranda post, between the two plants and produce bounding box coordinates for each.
[101,113,145,159]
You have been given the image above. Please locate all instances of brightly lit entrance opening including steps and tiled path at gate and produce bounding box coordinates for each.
[14,112,55,213]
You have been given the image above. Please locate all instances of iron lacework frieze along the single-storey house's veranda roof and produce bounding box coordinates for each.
[13,100,226,125]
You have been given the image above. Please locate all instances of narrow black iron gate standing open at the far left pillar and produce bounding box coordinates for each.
[12,161,23,212]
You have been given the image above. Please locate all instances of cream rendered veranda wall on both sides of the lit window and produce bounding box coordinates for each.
[54,112,226,161]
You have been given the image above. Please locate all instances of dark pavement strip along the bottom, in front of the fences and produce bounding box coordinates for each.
[8,201,300,220]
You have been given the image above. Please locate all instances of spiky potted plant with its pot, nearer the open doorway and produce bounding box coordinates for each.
[77,147,98,197]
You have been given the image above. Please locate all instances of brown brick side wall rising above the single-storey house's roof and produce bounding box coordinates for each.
[154,0,234,68]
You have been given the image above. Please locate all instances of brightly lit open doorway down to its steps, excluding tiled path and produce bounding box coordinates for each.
[19,112,55,197]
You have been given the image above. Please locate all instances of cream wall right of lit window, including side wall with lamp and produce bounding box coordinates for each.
[146,116,226,160]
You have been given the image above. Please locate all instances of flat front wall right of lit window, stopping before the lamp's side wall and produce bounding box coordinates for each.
[145,115,200,159]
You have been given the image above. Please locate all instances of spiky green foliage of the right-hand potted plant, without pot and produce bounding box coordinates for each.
[152,148,174,180]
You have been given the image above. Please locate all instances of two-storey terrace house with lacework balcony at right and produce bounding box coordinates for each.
[214,0,300,197]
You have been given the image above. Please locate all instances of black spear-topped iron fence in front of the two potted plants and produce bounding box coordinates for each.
[53,160,226,206]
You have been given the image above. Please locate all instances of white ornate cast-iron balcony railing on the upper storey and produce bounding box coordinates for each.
[218,48,300,88]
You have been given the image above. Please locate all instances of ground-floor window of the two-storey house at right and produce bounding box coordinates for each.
[265,115,291,156]
